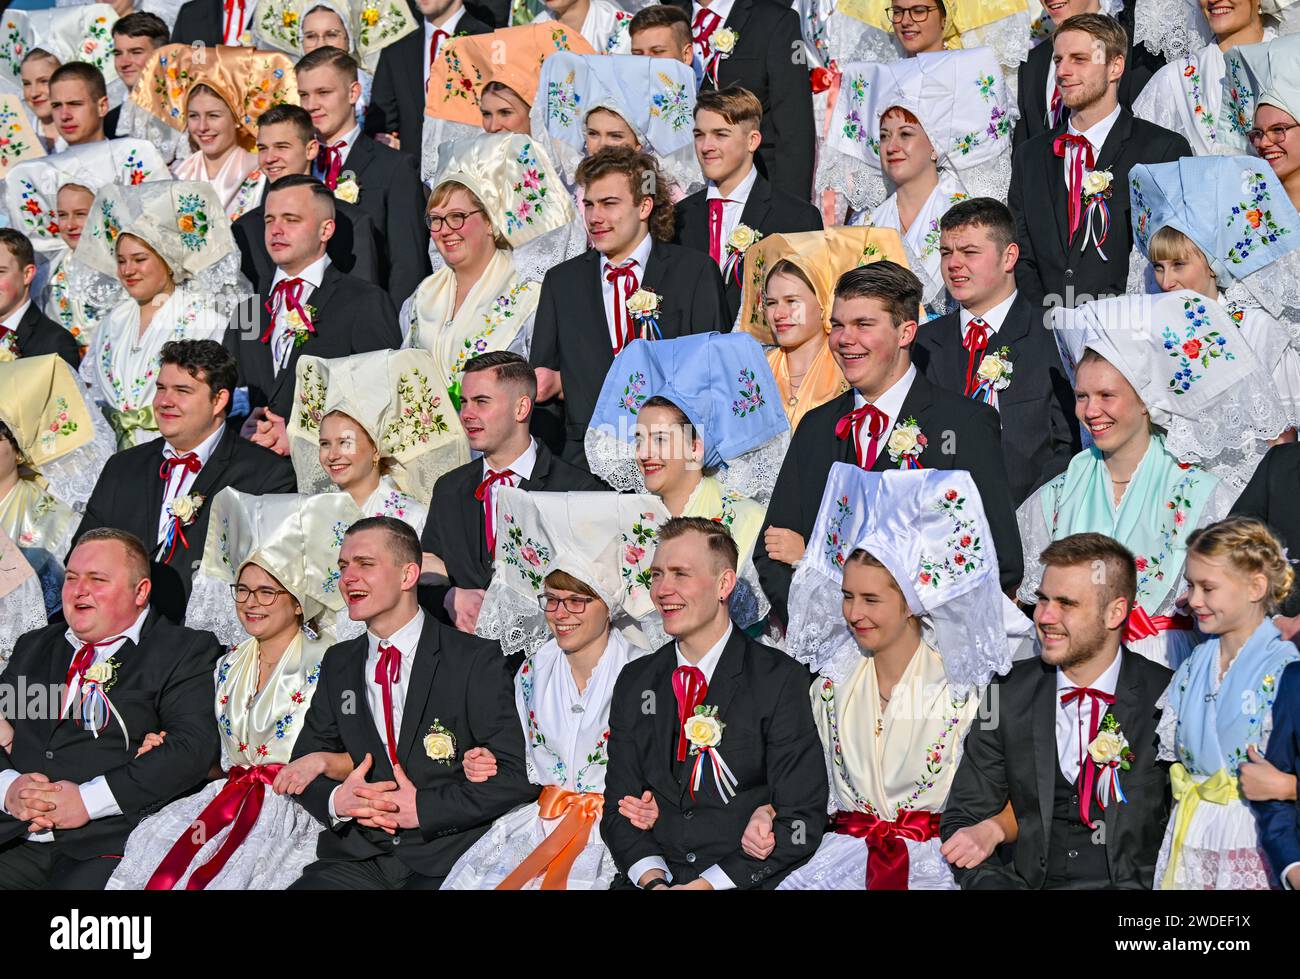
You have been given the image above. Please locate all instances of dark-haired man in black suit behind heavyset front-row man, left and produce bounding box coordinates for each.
[77,339,295,621]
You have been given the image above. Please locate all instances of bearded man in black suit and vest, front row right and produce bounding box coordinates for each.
[940,533,1173,891]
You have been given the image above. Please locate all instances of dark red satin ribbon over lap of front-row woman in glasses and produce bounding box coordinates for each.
[144,764,285,891]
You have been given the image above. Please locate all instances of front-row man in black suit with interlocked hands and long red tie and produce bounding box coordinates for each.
[293,516,537,891]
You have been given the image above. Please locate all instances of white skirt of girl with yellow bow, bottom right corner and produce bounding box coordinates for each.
[1156,776,1278,891]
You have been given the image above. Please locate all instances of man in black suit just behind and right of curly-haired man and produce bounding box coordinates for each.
[672,87,822,322]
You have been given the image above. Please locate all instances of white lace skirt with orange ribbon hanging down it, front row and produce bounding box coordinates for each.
[442,802,618,891]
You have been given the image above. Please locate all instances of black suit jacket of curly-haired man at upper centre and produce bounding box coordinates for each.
[529,241,732,468]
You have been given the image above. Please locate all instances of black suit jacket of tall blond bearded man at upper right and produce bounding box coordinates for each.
[1006,108,1192,308]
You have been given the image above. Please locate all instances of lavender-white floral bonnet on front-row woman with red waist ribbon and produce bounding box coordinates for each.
[785,463,1023,696]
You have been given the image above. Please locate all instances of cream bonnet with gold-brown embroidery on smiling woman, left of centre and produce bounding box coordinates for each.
[287,348,469,503]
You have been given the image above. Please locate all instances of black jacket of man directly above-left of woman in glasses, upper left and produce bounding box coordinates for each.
[343,133,430,309]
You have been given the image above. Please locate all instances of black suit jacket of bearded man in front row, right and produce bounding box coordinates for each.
[940,651,1173,891]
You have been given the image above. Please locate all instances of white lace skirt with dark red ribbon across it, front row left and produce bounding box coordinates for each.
[107,779,324,891]
